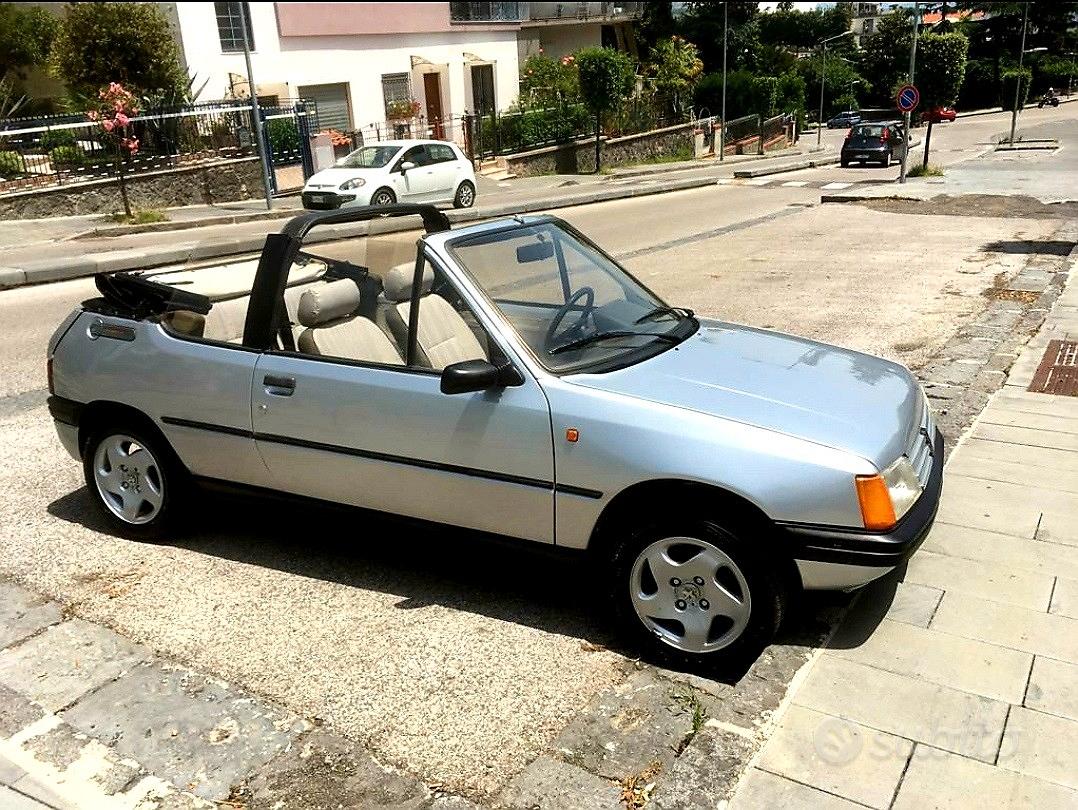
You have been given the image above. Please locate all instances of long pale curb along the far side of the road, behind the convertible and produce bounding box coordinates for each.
[0,177,716,289]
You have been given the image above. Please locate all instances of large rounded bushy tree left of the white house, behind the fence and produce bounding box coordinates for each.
[50,3,188,100]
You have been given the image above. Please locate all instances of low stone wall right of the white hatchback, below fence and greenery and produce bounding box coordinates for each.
[506,124,693,177]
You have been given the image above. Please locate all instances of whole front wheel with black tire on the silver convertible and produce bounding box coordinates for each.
[609,518,787,672]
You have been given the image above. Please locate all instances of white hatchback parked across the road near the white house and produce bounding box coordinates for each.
[303,140,475,210]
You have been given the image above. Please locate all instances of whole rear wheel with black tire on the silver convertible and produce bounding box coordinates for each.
[82,424,189,540]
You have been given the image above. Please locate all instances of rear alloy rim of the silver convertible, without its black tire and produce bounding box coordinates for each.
[94,434,165,525]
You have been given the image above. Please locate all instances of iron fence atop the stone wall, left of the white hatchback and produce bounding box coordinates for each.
[0,100,317,194]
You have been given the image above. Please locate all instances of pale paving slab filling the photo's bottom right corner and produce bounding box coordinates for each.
[894,745,1075,810]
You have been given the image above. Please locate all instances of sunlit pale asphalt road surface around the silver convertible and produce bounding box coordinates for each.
[0,99,1062,797]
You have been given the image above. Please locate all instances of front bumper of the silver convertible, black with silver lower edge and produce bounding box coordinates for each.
[778,428,943,588]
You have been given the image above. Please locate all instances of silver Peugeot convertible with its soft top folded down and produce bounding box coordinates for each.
[47,205,943,667]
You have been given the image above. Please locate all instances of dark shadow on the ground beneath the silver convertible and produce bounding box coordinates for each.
[47,488,851,684]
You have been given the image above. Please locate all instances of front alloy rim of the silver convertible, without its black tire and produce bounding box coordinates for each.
[630,537,751,654]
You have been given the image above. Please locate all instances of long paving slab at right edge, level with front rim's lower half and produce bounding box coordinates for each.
[929,592,1078,663]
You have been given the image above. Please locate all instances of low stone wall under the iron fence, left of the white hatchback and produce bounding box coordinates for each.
[0,157,265,219]
